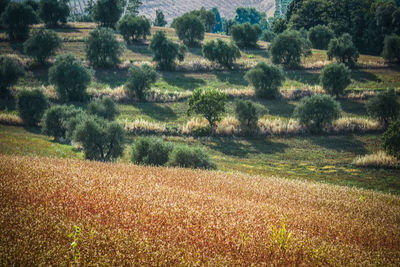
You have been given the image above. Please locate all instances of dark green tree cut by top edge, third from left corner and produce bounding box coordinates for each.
[93,0,123,28]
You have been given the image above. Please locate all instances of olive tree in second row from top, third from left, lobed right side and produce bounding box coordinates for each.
[149,31,186,70]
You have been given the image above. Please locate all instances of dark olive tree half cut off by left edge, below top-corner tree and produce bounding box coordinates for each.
[0,56,25,98]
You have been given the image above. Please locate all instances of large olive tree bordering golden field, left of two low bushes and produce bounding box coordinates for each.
[73,117,125,161]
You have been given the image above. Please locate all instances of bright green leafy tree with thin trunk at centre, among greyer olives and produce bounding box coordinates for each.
[187,89,227,127]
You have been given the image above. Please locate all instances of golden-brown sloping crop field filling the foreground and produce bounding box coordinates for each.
[0,156,400,266]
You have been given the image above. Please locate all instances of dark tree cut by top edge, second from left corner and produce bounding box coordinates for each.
[39,0,69,27]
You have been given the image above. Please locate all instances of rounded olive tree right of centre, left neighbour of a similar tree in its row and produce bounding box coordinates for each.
[245,62,285,98]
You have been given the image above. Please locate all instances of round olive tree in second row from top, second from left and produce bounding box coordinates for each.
[85,28,123,67]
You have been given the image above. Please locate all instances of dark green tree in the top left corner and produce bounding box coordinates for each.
[1,2,38,41]
